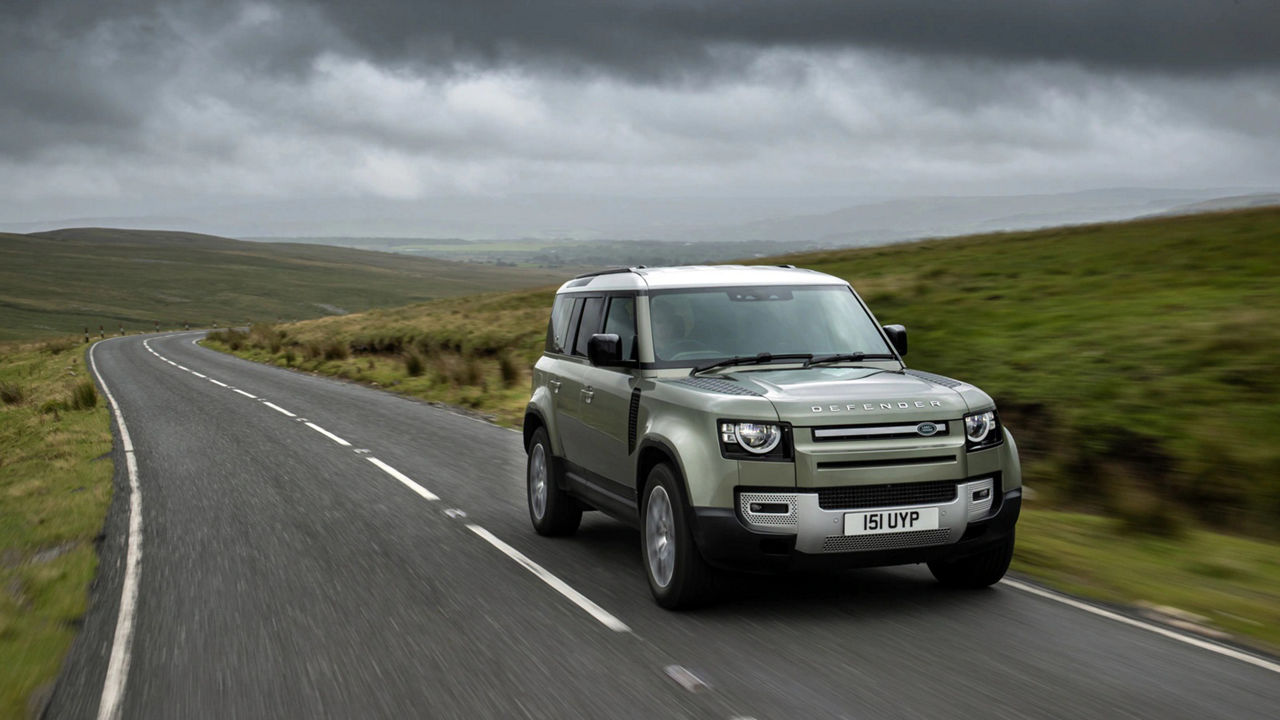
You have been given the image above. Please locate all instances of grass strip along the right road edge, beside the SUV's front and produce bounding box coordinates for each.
[1012,510,1280,652]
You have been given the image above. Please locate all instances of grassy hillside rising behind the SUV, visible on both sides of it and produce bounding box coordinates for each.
[209,208,1280,537]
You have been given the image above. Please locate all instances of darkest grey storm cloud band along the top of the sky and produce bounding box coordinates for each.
[302,0,1280,77]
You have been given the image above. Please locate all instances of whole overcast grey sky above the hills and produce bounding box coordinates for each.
[0,0,1280,222]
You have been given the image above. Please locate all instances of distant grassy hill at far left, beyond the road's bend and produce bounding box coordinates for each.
[0,228,567,341]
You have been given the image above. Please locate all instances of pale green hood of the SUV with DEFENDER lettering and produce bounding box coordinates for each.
[732,368,972,427]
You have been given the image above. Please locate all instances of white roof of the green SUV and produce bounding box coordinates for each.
[559,265,849,292]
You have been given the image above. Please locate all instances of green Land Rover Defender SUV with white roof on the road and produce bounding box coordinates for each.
[524,266,1021,607]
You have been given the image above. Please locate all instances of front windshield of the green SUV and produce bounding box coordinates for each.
[649,286,892,366]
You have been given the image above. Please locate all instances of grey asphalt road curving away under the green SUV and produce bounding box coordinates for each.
[47,334,1280,720]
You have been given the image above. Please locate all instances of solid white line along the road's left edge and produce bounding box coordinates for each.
[88,342,142,720]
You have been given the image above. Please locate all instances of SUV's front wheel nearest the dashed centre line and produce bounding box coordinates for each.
[640,462,714,610]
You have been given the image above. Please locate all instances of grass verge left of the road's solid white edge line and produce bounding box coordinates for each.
[0,341,113,717]
